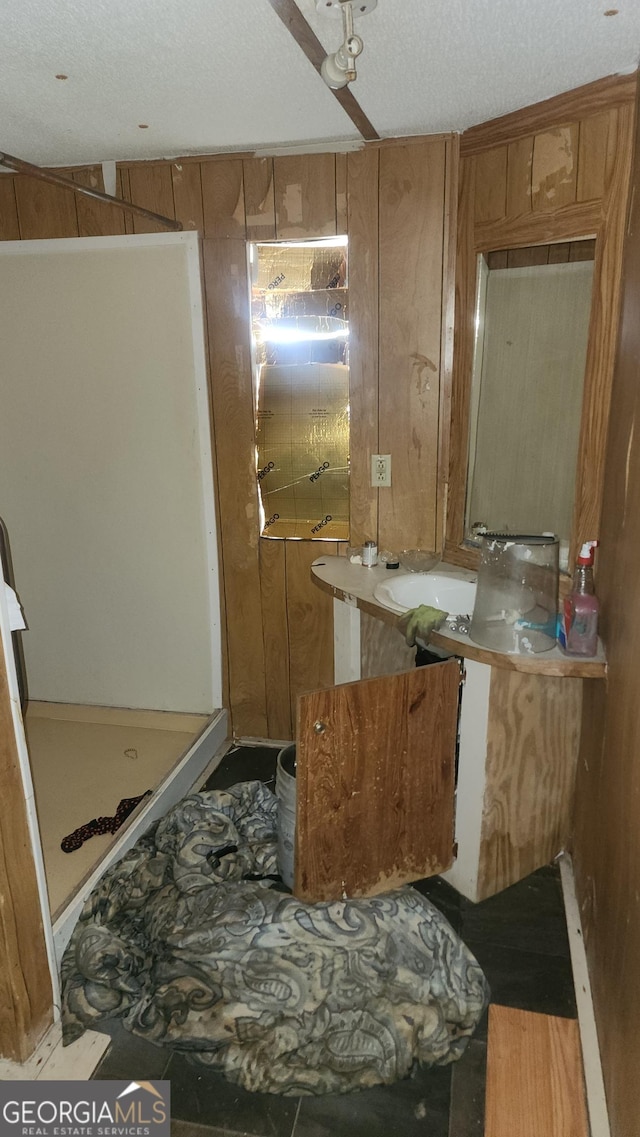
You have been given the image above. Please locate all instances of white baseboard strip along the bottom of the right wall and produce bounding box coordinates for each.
[558,853,610,1137]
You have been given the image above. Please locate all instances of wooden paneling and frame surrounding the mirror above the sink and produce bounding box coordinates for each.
[443,84,633,577]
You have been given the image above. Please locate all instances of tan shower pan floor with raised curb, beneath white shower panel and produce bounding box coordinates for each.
[25,703,226,955]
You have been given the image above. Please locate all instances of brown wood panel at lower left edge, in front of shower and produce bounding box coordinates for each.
[0,653,53,1062]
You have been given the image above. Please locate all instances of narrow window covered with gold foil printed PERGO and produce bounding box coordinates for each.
[249,236,349,540]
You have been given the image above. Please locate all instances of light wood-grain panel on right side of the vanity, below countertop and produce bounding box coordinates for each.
[479,667,582,899]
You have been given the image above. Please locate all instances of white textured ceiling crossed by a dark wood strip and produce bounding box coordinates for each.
[0,0,640,165]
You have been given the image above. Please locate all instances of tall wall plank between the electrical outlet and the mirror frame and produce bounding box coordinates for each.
[379,140,444,550]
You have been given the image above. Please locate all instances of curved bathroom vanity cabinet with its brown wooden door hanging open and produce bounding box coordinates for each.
[294,556,606,901]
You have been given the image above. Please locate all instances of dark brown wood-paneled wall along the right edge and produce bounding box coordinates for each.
[574,77,640,1137]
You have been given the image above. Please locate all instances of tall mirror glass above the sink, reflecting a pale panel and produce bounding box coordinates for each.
[465,240,596,557]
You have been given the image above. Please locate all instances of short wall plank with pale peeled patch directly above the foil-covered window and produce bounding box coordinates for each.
[274,153,336,240]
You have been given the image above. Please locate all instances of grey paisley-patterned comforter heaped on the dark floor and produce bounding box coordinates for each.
[61,781,488,1095]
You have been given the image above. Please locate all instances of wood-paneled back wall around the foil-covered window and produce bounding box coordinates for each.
[0,136,457,739]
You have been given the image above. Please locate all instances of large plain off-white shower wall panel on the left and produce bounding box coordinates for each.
[0,234,222,714]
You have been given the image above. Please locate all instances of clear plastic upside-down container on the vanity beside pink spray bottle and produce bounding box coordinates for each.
[469,533,558,655]
